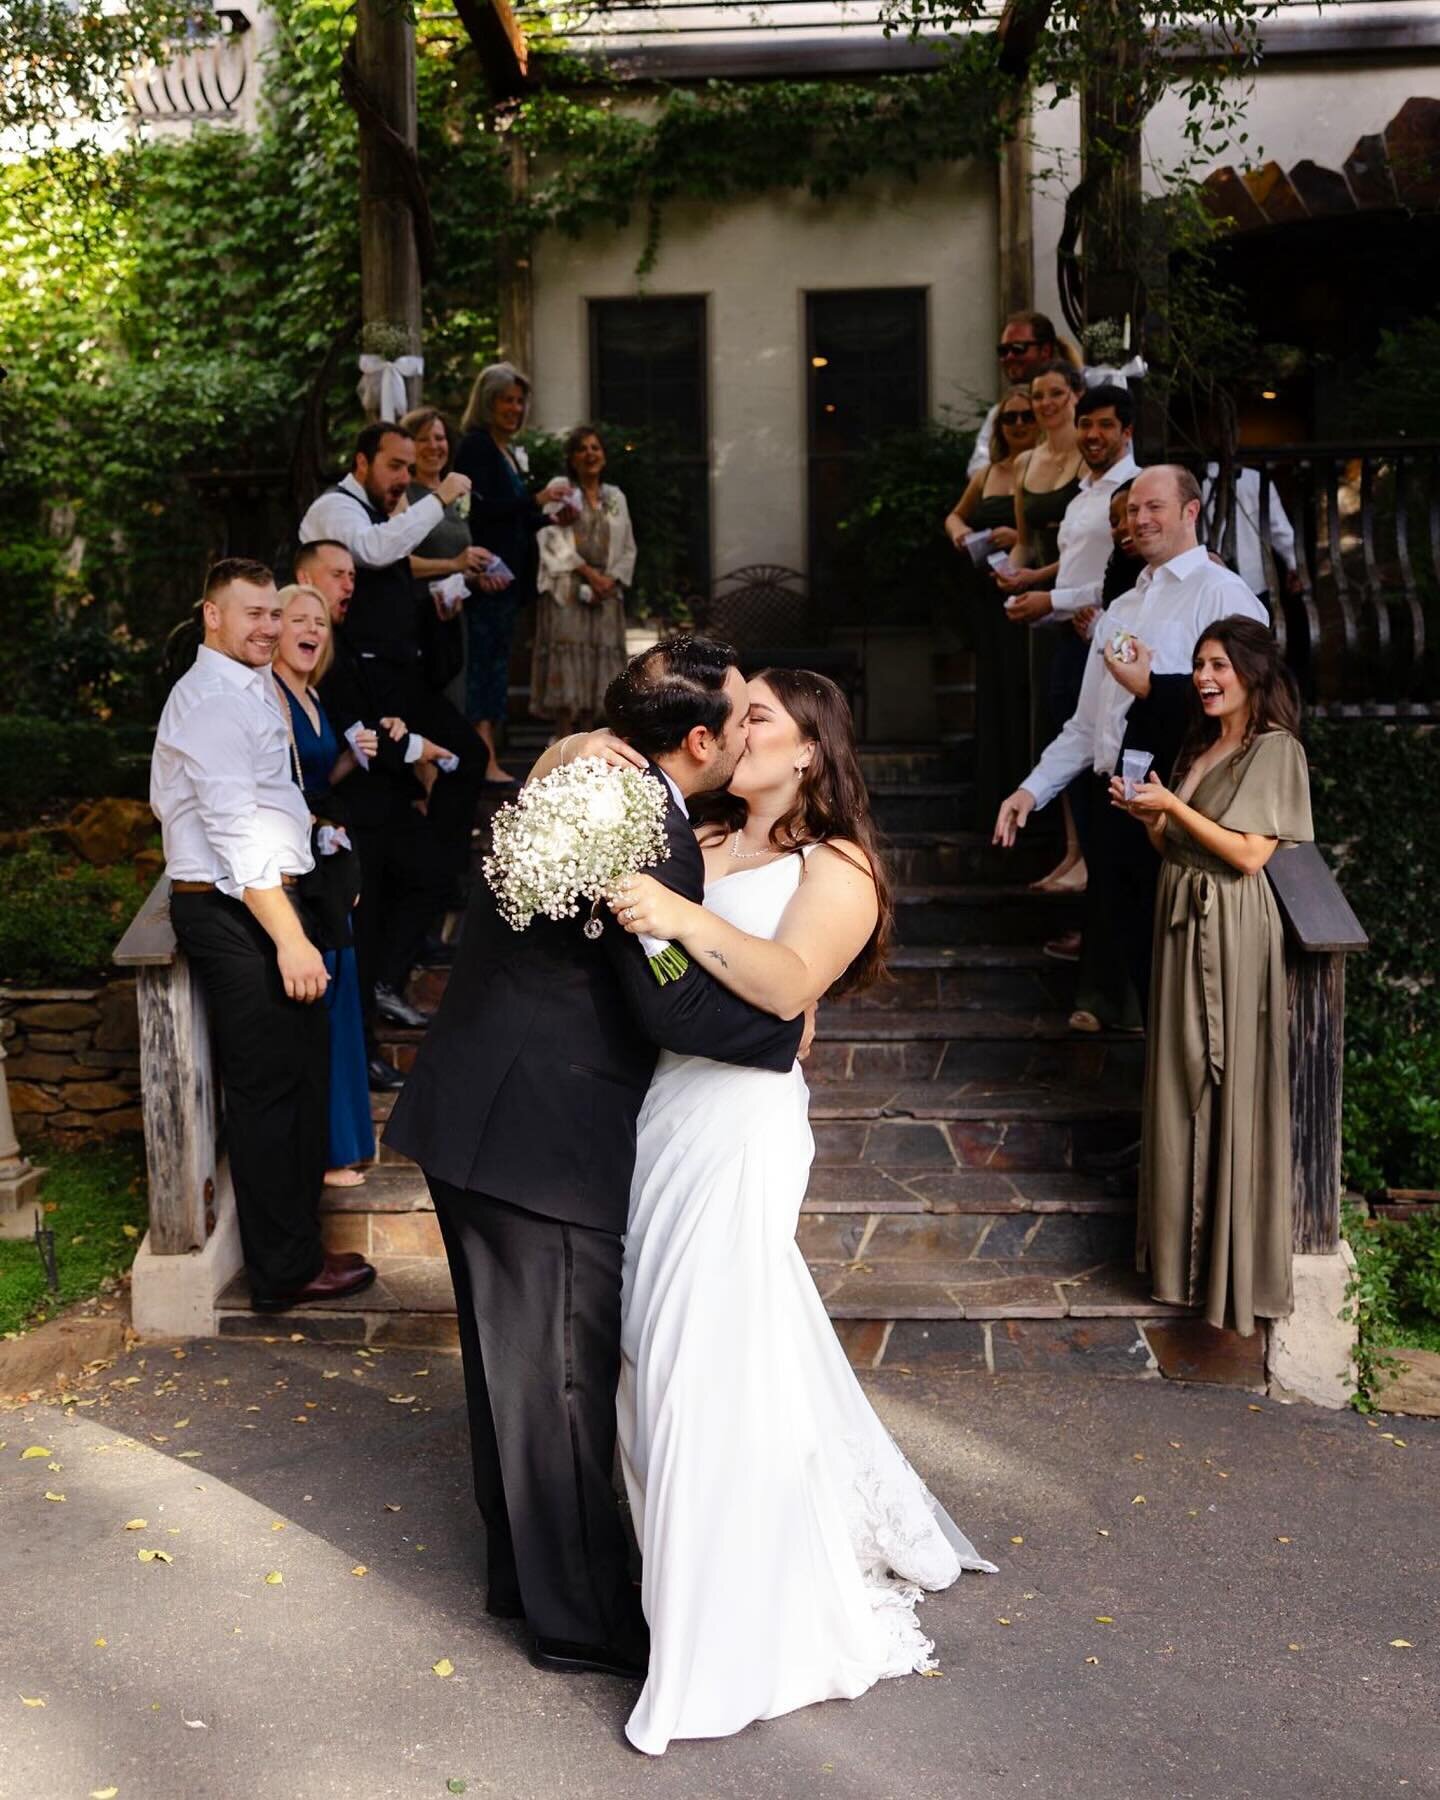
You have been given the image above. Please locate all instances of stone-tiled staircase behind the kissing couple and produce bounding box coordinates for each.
[220,740,1238,1386]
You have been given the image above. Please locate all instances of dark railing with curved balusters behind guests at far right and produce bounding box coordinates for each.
[1213,439,1440,718]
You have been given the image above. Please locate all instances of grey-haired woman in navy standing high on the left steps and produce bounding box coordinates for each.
[455,362,578,783]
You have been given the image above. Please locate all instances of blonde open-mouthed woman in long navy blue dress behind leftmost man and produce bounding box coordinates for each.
[274,587,374,1188]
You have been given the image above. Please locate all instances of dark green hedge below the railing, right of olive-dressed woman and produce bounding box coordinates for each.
[1305,722,1440,1192]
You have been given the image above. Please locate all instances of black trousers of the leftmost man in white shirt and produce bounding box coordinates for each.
[169,893,329,1300]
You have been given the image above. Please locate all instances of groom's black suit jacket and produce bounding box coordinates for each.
[385,774,803,1231]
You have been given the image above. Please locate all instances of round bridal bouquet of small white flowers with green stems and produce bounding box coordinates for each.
[482,756,689,985]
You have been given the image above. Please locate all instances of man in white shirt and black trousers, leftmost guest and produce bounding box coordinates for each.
[149,558,374,1310]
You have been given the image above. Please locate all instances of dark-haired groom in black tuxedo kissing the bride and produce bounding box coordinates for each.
[385,637,803,1676]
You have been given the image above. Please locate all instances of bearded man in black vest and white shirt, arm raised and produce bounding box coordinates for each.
[301,421,484,900]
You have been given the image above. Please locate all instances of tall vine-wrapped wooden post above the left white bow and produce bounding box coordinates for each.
[355,0,421,407]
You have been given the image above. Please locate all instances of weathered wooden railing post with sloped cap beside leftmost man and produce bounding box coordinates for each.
[112,875,221,1256]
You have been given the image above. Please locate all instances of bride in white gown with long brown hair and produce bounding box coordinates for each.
[610,670,994,1755]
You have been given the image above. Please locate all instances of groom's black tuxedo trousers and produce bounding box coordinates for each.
[425,1175,644,1654]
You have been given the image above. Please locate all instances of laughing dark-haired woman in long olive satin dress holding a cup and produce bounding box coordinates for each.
[1111,617,1314,1336]
